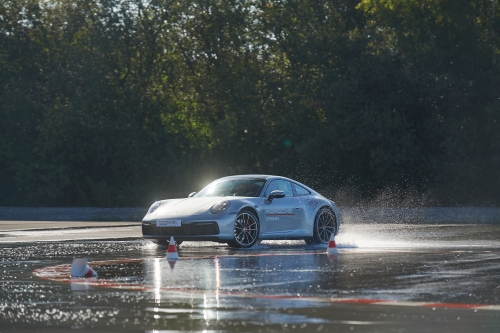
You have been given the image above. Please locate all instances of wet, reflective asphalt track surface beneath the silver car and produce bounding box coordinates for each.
[0,224,500,333]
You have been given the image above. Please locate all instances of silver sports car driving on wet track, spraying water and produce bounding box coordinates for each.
[142,175,341,248]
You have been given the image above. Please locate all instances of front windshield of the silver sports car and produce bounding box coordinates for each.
[195,178,266,197]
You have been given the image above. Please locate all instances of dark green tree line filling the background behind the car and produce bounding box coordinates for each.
[0,0,500,206]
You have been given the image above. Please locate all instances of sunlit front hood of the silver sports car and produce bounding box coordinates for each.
[150,197,233,217]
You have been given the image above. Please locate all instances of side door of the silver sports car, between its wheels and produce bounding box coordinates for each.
[261,179,303,234]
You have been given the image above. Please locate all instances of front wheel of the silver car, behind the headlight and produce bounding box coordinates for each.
[227,210,260,249]
